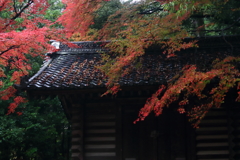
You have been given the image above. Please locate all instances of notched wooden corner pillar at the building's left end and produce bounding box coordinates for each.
[71,104,83,160]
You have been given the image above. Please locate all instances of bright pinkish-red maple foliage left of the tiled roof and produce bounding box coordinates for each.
[0,0,63,114]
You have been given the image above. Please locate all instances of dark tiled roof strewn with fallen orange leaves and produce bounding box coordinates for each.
[25,36,240,90]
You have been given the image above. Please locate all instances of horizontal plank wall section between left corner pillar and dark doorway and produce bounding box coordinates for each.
[84,103,117,160]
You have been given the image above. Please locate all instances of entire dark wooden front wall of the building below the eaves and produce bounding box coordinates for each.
[59,90,240,160]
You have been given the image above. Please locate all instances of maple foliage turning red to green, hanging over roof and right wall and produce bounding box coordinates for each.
[60,0,240,127]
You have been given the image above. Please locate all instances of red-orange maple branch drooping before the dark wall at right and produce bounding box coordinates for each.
[138,57,240,127]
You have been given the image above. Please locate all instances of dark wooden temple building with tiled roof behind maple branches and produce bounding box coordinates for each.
[21,36,240,160]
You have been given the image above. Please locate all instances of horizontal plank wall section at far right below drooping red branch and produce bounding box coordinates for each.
[196,104,240,160]
